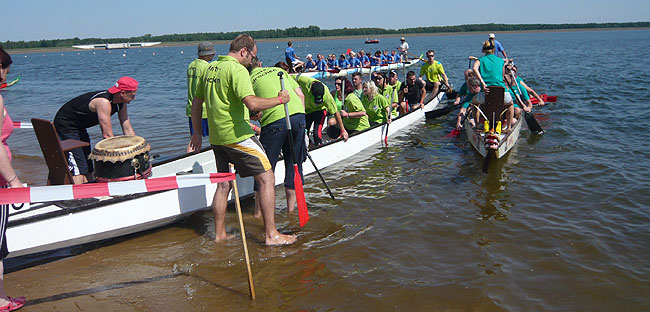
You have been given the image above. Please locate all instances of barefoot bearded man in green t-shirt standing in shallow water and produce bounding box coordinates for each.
[190,34,296,245]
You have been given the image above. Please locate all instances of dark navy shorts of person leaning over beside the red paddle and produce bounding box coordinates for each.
[255,114,307,190]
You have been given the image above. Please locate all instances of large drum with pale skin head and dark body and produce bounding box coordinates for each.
[89,135,151,182]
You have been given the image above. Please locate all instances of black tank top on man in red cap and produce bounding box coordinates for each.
[54,90,124,132]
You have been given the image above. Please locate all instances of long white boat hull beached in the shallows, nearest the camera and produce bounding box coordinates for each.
[7,93,443,257]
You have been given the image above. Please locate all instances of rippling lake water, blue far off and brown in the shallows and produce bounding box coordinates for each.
[1,30,650,311]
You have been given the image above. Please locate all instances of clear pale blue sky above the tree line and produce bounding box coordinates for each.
[0,0,650,42]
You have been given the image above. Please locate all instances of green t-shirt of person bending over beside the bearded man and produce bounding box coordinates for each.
[251,67,305,127]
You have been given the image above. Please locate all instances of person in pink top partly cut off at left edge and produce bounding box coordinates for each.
[0,47,27,311]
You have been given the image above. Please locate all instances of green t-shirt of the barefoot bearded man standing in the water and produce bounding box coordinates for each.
[195,55,256,145]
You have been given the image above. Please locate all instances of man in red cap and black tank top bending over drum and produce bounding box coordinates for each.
[54,76,138,184]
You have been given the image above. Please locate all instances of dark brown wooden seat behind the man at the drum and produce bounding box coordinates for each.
[32,118,90,185]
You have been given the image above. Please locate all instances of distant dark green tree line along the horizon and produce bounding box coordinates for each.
[2,22,650,49]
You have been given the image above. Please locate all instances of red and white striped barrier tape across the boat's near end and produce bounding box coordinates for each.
[0,173,235,204]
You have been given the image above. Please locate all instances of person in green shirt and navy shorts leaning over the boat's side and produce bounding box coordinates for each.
[249,59,307,214]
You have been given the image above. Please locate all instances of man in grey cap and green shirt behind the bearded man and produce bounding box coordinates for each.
[185,42,217,146]
